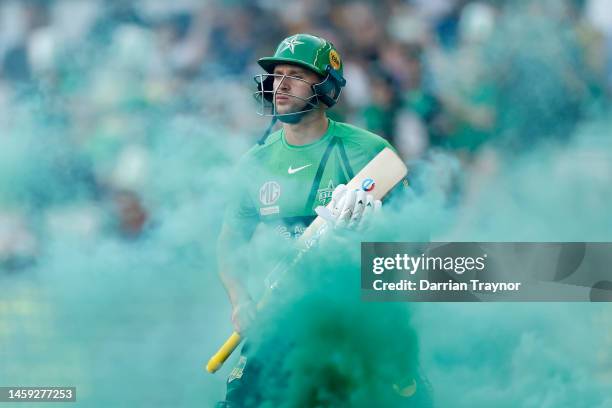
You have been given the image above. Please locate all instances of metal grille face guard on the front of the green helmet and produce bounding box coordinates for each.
[253,74,319,124]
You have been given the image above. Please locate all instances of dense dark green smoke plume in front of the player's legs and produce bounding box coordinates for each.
[251,241,418,407]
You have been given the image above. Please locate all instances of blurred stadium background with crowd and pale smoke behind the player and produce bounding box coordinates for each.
[0,0,612,407]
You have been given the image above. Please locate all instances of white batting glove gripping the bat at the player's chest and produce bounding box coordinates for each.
[315,184,382,229]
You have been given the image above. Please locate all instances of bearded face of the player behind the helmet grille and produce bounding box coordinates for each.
[273,64,319,114]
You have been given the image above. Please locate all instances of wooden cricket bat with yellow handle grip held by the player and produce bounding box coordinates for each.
[206,147,408,373]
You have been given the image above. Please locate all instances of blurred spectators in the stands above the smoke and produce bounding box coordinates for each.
[0,0,612,269]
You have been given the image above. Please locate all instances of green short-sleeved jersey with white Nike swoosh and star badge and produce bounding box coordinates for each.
[225,119,390,237]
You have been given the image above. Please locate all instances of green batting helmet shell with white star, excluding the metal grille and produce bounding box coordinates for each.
[257,34,346,106]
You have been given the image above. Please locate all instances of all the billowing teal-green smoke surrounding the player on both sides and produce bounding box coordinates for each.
[0,1,612,408]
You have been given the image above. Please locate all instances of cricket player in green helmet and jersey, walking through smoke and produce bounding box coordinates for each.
[217,34,430,407]
